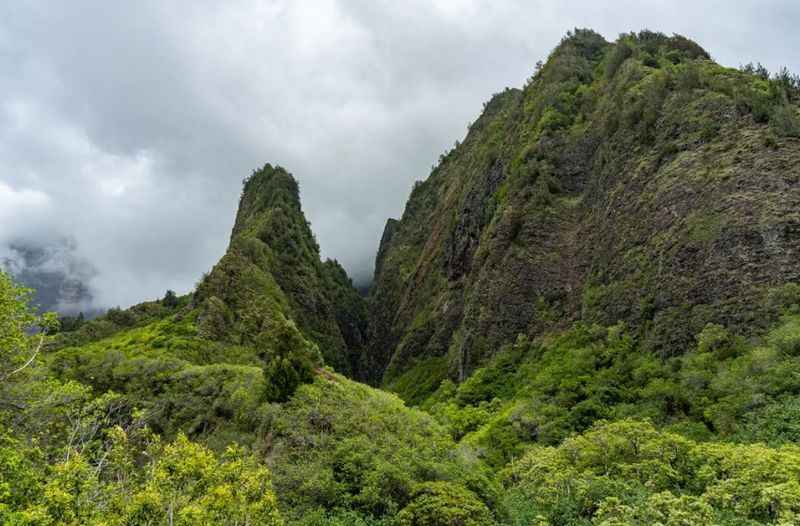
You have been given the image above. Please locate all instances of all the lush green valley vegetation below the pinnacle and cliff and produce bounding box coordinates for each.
[7,274,800,525]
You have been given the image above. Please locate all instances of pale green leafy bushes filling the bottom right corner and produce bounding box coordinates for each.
[505,420,800,525]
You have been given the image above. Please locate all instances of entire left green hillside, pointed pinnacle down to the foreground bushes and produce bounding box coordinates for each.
[0,165,500,524]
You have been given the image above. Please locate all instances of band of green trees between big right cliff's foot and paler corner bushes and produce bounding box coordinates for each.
[422,310,800,467]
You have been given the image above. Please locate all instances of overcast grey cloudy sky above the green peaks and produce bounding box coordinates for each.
[0,0,800,312]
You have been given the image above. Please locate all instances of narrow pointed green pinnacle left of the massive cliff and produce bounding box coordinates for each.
[194,164,366,376]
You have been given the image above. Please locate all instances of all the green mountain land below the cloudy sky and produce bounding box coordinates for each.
[0,30,800,526]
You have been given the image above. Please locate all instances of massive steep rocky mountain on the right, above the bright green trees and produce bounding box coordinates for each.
[370,30,800,392]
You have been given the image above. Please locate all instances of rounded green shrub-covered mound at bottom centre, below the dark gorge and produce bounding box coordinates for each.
[270,373,498,524]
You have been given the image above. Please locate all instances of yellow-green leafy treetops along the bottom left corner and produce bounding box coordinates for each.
[0,428,283,526]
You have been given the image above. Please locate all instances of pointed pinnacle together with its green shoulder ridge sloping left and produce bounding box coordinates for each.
[38,165,366,447]
